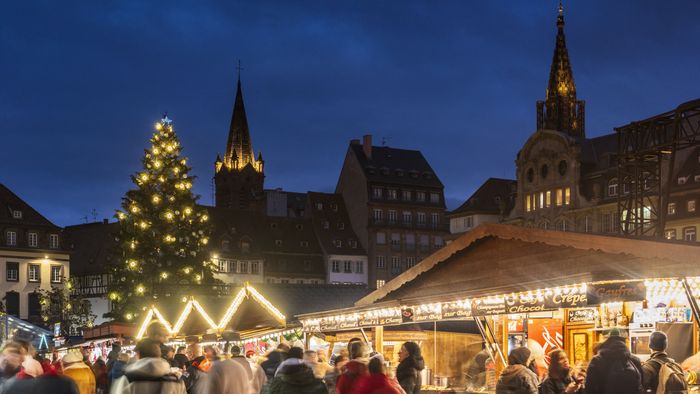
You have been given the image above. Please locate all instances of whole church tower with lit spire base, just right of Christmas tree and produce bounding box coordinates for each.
[214,75,265,212]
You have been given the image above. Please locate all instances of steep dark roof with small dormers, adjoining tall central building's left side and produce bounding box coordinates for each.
[306,192,366,255]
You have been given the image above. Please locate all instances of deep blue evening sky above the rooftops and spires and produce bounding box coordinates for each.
[0,0,700,225]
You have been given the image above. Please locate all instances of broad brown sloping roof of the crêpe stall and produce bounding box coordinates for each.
[355,224,700,308]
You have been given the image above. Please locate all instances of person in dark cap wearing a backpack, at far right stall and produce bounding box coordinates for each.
[642,331,688,393]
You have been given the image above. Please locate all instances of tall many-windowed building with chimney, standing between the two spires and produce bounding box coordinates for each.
[335,135,448,288]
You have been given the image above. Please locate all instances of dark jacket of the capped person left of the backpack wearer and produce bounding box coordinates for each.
[586,336,642,394]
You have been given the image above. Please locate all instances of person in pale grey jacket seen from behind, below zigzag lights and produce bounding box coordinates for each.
[112,338,187,394]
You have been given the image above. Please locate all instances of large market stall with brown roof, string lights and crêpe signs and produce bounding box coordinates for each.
[298,224,700,392]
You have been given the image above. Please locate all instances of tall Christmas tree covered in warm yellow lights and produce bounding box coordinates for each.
[108,116,214,321]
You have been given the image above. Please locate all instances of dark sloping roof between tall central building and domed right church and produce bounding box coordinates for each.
[449,178,517,216]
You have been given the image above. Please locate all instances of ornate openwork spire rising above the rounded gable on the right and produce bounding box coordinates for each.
[537,1,585,137]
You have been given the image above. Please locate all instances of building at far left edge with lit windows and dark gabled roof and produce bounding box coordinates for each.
[0,184,70,324]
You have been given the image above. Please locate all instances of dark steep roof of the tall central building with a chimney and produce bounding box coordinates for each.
[350,143,443,188]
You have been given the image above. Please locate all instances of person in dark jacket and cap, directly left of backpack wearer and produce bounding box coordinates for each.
[585,328,642,394]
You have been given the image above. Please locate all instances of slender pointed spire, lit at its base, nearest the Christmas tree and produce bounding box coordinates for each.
[224,78,255,167]
